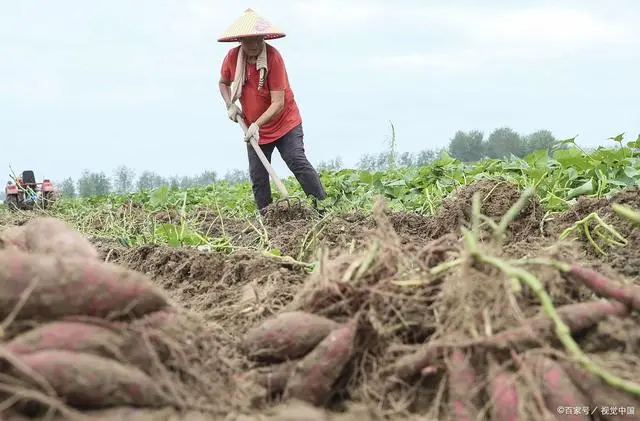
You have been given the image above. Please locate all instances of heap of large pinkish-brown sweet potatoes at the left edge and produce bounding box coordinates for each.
[0,218,180,415]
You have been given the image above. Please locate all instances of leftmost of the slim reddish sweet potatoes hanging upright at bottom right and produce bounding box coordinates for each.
[447,349,479,421]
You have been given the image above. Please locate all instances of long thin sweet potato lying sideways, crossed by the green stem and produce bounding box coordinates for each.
[395,300,630,380]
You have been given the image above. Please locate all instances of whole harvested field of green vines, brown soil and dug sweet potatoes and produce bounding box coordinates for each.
[0,139,640,421]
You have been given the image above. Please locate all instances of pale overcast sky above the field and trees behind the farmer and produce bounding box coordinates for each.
[0,0,640,180]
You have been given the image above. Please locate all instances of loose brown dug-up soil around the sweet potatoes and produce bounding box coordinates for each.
[0,180,640,421]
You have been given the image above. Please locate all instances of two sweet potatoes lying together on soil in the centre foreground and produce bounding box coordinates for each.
[239,311,371,406]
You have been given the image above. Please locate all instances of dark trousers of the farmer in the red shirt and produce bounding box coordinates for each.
[247,124,326,210]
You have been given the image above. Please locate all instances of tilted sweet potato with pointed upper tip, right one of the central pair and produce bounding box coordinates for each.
[285,317,359,406]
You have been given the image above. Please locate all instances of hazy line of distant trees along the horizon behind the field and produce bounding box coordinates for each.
[43,125,557,197]
